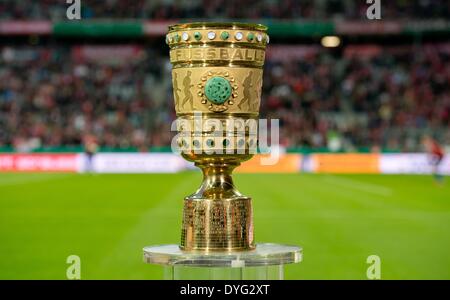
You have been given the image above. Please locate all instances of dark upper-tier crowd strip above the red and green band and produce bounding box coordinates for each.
[0,0,450,20]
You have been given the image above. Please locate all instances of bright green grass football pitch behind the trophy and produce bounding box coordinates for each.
[0,172,450,279]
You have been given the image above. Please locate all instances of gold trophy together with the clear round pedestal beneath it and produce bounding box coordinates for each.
[144,23,301,279]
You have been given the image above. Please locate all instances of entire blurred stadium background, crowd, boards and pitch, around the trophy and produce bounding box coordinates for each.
[0,0,450,279]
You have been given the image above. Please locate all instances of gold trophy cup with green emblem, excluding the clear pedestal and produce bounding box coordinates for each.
[166,23,269,251]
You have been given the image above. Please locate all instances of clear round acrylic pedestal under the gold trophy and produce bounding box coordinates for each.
[144,244,302,280]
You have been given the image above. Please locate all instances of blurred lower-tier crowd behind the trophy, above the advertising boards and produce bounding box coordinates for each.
[0,44,450,151]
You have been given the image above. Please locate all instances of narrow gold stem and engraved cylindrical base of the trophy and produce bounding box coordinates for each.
[180,161,254,251]
